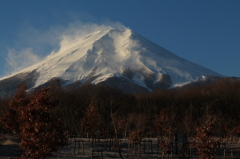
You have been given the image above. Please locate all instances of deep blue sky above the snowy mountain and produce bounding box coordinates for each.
[0,0,240,77]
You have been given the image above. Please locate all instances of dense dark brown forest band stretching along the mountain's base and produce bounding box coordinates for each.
[0,78,240,158]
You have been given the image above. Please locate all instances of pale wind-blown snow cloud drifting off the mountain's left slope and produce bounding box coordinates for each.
[5,21,126,75]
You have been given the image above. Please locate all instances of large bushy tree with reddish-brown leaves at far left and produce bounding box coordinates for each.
[2,86,67,159]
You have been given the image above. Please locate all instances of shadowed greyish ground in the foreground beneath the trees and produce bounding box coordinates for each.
[0,138,240,159]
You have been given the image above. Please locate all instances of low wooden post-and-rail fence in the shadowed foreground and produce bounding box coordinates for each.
[65,137,240,159]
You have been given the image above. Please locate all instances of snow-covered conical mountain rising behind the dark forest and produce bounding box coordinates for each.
[0,29,221,94]
